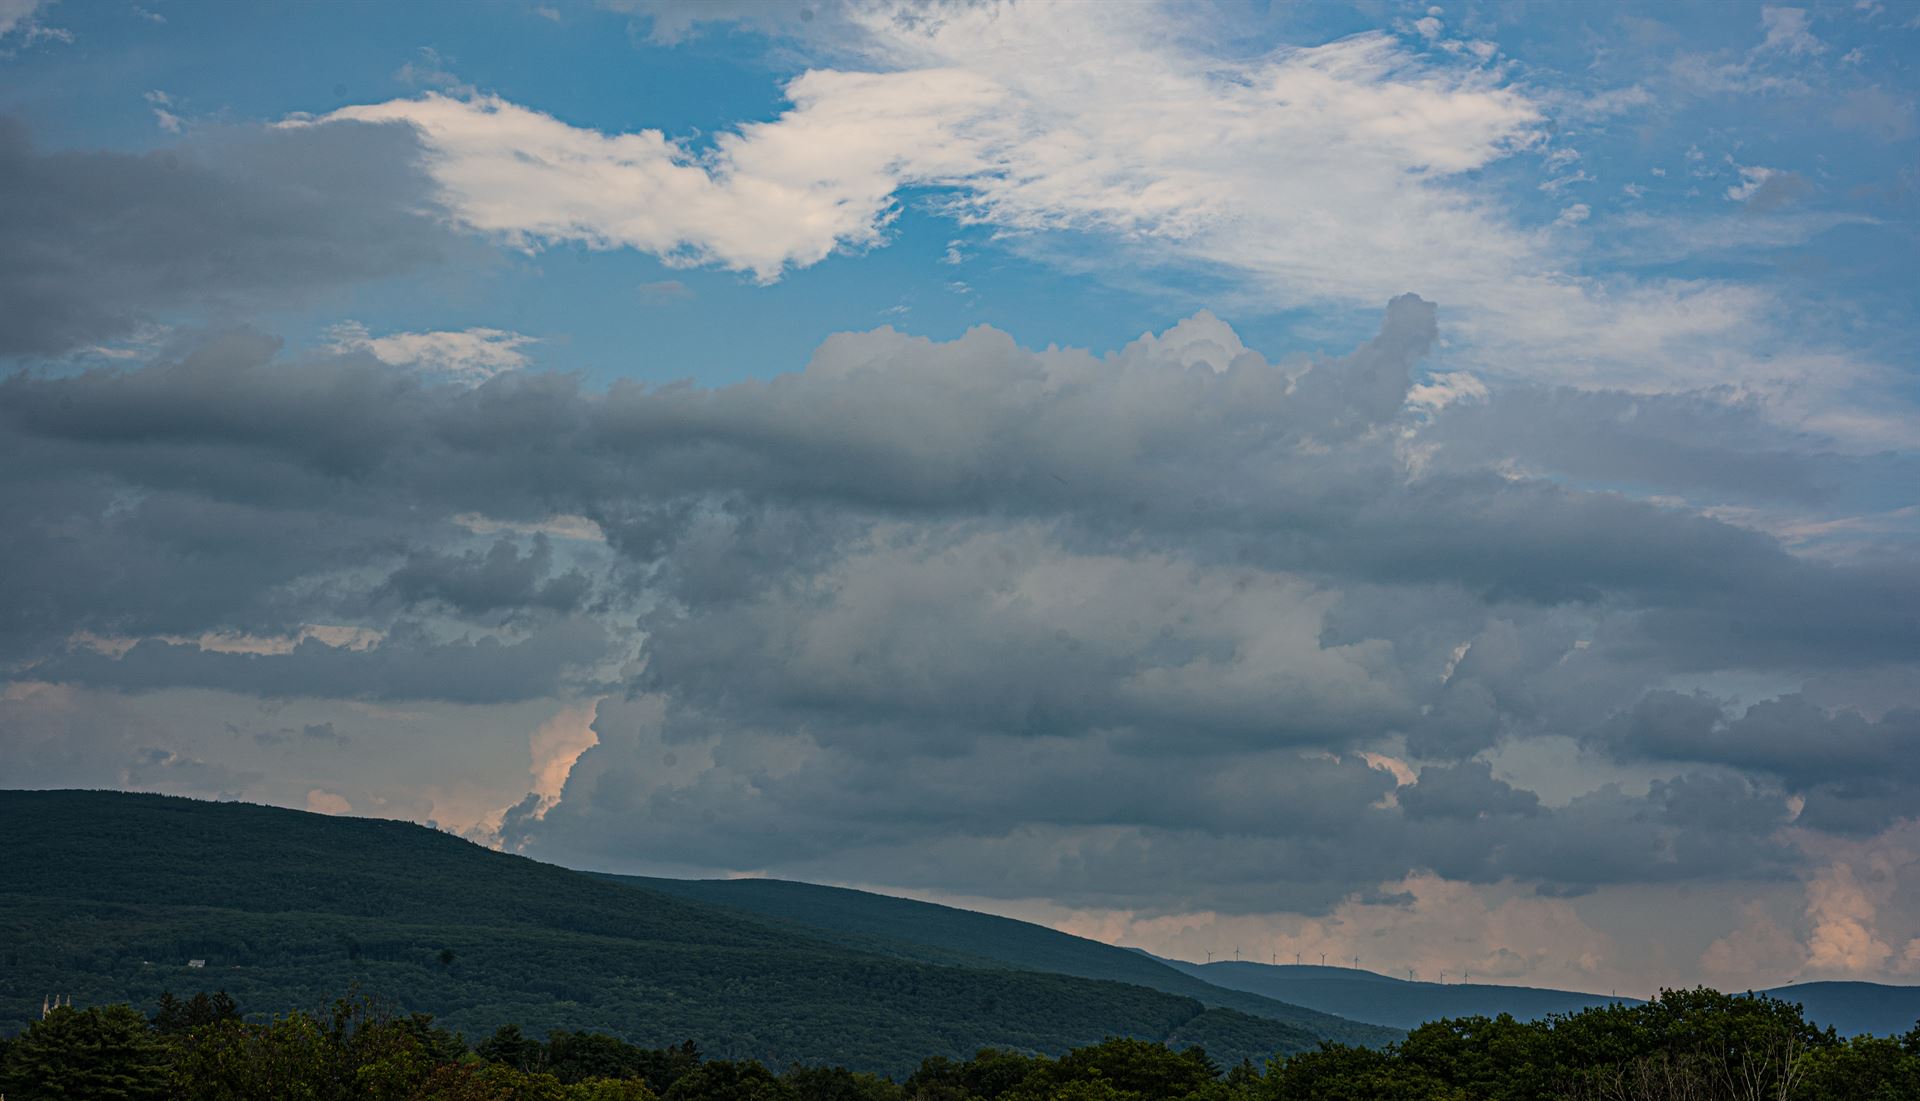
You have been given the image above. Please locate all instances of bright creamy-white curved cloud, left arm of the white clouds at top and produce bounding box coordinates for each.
[307,83,993,282]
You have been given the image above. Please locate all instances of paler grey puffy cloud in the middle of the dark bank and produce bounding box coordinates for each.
[641,528,1409,747]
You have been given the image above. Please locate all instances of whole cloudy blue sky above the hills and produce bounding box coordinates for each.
[0,0,1920,995]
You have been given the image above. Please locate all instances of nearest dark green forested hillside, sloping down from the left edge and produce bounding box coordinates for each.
[0,792,1351,1072]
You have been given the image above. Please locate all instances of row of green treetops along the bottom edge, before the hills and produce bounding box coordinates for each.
[0,988,1920,1101]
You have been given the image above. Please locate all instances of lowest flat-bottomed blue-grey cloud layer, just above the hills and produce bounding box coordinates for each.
[516,697,1793,913]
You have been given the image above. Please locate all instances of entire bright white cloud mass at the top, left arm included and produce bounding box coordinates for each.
[311,27,1542,300]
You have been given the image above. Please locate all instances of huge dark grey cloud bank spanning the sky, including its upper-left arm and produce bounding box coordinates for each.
[0,115,1920,911]
